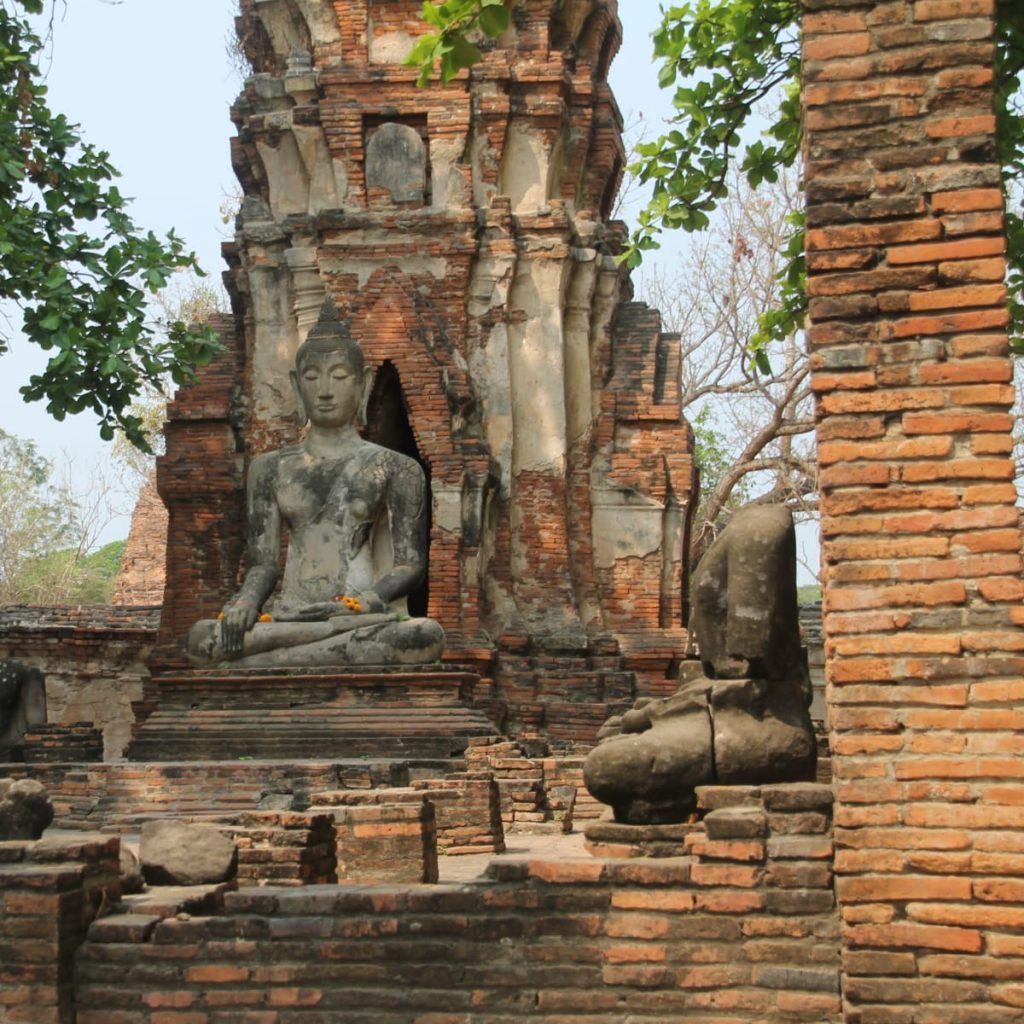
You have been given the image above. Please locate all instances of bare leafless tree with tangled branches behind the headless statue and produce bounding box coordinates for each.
[640,169,817,564]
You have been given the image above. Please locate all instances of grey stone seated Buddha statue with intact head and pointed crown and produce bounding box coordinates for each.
[187,298,444,668]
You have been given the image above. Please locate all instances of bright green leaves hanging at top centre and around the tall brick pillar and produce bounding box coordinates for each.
[407,0,1024,358]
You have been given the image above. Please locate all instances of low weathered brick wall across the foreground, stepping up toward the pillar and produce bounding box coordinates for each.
[70,786,839,1024]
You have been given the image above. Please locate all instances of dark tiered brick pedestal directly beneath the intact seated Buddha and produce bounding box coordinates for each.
[128,667,495,762]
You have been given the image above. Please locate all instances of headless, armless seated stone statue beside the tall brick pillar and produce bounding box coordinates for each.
[584,506,816,824]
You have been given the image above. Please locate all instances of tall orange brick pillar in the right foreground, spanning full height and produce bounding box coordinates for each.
[804,0,1024,1024]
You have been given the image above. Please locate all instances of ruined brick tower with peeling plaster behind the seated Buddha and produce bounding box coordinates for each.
[149,0,695,741]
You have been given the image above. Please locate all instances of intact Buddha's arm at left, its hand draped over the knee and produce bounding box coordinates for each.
[220,454,281,653]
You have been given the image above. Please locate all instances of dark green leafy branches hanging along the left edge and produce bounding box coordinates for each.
[0,0,217,450]
